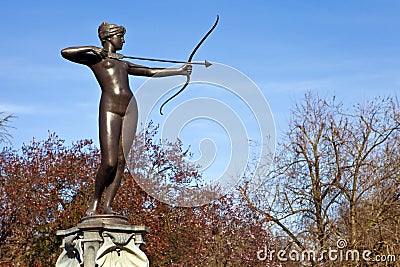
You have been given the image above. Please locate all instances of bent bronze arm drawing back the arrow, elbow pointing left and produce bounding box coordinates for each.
[61,46,102,65]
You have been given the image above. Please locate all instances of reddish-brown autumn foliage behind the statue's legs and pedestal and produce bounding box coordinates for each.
[0,128,269,266]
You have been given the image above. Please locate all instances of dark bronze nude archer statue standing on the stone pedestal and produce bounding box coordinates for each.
[61,22,192,216]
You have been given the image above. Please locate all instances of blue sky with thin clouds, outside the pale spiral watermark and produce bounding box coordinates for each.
[0,0,400,151]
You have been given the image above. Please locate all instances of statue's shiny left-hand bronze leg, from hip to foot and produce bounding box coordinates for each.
[86,111,122,218]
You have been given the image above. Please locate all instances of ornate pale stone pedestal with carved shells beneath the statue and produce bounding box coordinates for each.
[56,215,149,267]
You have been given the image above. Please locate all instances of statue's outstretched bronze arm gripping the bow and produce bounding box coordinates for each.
[125,61,192,77]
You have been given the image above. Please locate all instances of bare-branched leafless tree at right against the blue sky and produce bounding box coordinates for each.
[242,93,400,264]
